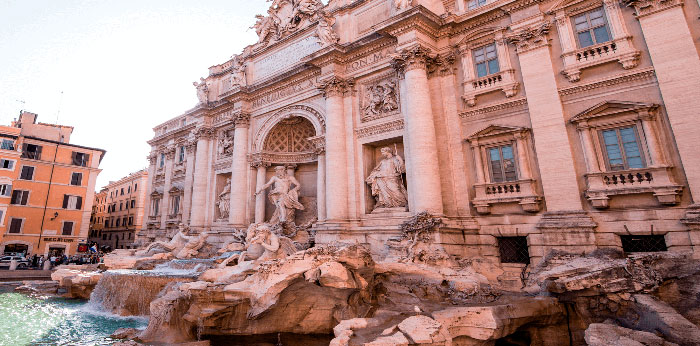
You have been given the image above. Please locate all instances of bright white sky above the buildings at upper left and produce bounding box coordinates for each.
[0,0,269,190]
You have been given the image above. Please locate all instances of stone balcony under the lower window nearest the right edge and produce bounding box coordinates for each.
[586,167,683,209]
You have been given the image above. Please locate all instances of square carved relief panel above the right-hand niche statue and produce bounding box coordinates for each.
[360,73,401,122]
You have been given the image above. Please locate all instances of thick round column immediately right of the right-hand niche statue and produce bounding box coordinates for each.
[392,46,443,215]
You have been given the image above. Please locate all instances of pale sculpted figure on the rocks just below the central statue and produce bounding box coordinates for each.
[219,223,297,268]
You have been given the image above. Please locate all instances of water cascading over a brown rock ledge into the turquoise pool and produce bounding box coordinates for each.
[88,260,213,316]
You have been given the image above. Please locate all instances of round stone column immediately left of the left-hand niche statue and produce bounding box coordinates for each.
[190,127,214,227]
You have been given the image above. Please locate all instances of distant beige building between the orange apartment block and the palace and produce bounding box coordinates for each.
[89,169,148,249]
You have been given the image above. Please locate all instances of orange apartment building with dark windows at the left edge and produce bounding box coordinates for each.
[0,112,105,255]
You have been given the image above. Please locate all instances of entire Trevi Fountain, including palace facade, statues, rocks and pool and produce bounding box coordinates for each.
[6,0,700,346]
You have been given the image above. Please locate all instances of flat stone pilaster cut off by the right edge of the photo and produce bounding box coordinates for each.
[626,0,700,200]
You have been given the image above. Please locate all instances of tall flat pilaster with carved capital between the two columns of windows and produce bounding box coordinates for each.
[508,18,583,211]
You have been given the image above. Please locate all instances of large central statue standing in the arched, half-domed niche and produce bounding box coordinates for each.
[255,166,304,223]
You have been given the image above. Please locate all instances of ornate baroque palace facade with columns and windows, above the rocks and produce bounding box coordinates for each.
[145,0,700,267]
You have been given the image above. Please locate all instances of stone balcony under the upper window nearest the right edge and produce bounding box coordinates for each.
[561,37,640,82]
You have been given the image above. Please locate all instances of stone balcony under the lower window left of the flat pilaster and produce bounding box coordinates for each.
[472,179,541,214]
